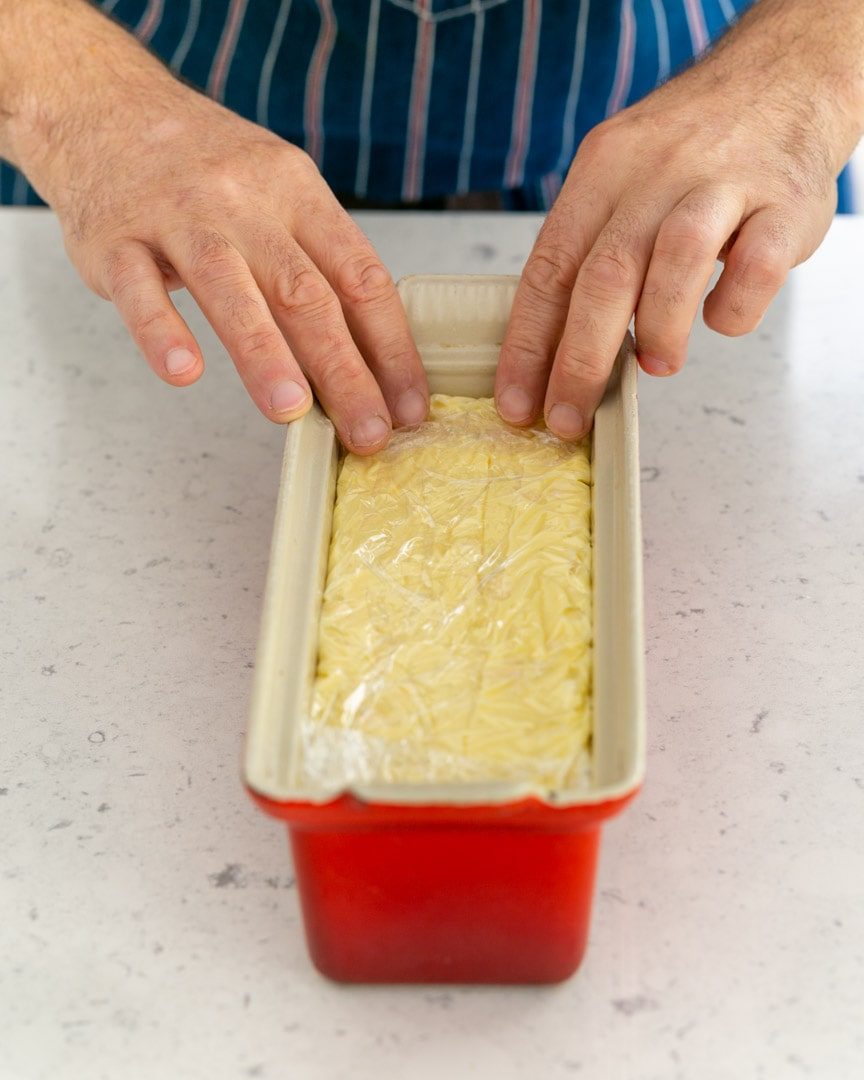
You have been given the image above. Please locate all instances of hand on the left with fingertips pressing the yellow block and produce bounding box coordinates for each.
[6,4,429,454]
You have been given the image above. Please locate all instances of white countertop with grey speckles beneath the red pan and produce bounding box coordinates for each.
[0,210,864,1080]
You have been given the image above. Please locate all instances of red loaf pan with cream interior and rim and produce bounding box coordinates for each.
[239,276,645,983]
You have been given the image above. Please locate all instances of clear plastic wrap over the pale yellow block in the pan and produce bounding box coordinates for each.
[299,395,591,788]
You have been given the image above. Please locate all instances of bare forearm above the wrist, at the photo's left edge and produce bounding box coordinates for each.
[0,0,173,201]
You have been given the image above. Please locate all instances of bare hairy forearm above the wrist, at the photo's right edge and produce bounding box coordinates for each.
[704,0,864,171]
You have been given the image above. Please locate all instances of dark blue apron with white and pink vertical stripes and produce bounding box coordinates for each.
[0,0,848,210]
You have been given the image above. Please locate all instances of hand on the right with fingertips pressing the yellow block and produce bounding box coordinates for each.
[496,0,862,438]
